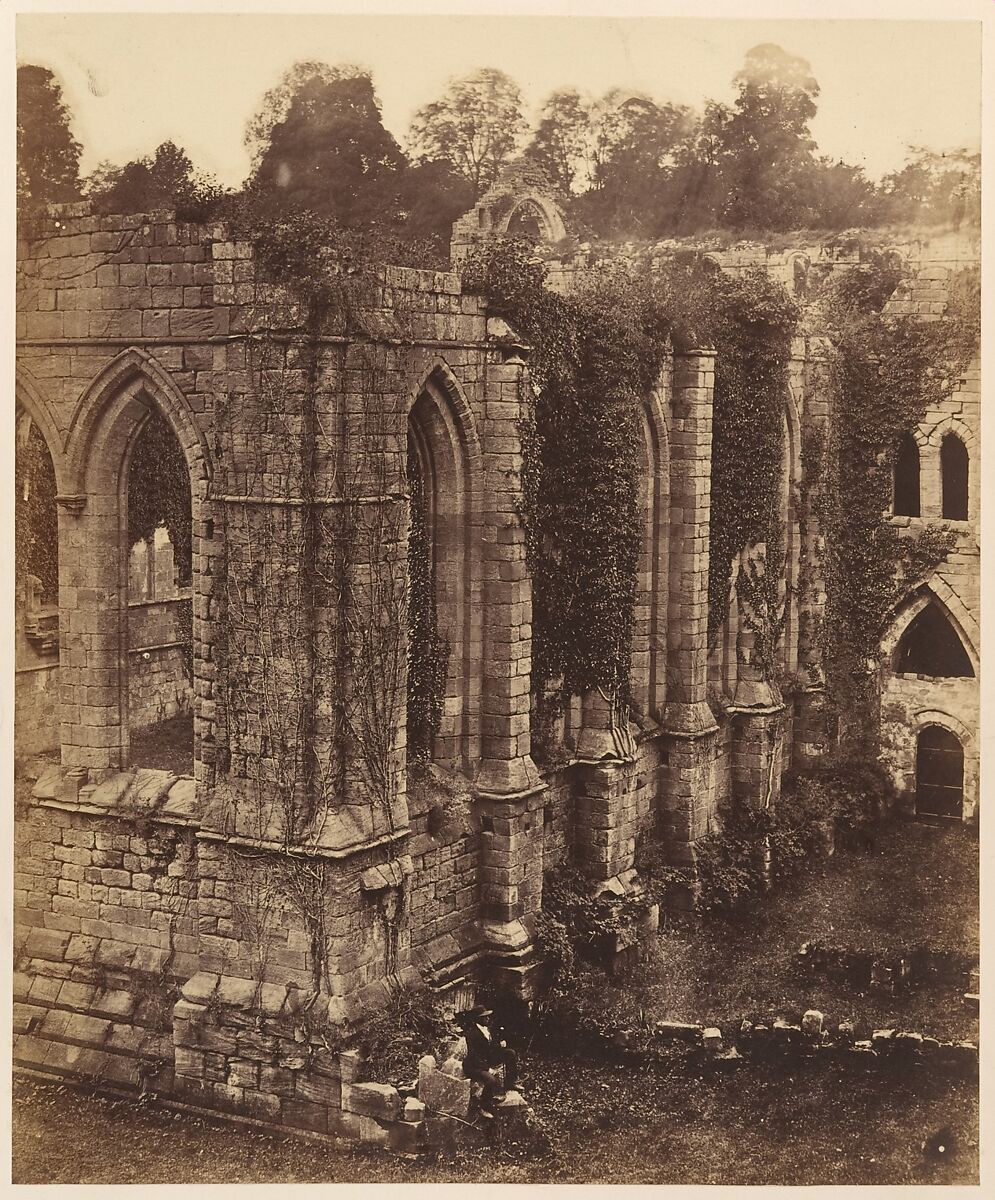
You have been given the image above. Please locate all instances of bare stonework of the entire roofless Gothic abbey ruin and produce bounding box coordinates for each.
[13,177,979,1148]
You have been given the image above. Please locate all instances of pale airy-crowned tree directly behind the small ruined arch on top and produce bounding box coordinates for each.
[409,67,526,196]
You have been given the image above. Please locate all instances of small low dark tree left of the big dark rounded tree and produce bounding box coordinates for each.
[86,142,218,215]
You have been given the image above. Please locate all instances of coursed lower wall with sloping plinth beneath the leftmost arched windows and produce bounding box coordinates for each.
[13,773,198,1091]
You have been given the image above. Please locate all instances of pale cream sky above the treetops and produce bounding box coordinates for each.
[16,12,981,185]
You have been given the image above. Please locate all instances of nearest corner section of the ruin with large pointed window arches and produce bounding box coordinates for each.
[17,210,541,1130]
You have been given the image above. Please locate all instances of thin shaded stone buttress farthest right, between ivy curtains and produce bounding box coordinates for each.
[792,337,832,767]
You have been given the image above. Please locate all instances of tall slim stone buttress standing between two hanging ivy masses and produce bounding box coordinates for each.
[661,349,718,862]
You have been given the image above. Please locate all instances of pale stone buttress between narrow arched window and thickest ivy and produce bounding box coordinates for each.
[474,346,545,990]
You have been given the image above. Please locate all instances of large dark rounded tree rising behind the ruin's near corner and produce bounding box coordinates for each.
[246,65,407,227]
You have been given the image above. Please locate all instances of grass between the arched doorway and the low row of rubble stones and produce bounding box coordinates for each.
[643,821,978,1039]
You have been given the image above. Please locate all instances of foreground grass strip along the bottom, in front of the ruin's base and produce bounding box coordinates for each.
[13,1058,978,1184]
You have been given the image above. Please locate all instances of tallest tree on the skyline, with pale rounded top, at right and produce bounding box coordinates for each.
[723,43,819,229]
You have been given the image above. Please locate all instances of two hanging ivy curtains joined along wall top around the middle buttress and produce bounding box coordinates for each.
[463,240,797,720]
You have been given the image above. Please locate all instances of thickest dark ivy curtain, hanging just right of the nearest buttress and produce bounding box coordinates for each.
[464,240,666,702]
